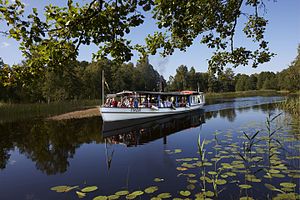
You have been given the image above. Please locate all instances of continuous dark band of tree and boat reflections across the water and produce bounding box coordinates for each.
[0,104,276,175]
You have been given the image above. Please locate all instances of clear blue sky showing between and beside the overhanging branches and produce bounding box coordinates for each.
[0,0,300,79]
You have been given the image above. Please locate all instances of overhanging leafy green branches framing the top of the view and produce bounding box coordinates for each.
[0,0,274,80]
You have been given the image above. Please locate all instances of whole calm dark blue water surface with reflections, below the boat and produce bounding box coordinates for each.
[0,97,300,200]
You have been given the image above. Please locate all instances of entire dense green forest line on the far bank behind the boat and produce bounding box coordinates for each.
[0,45,300,102]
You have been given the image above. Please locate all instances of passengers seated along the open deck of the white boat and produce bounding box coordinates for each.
[105,96,187,108]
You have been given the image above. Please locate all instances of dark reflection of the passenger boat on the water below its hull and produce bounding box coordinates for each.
[103,109,205,147]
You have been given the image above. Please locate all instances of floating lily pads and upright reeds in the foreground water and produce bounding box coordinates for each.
[51,114,300,200]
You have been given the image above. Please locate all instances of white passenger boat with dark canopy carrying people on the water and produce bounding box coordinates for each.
[100,91,205,122]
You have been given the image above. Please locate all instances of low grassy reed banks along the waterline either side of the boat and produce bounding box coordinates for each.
[0,90,300,123]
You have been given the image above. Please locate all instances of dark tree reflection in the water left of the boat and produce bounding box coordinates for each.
[0,117,103,174]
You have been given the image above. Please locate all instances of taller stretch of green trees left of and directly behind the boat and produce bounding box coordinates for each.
[0,59,166,102]
